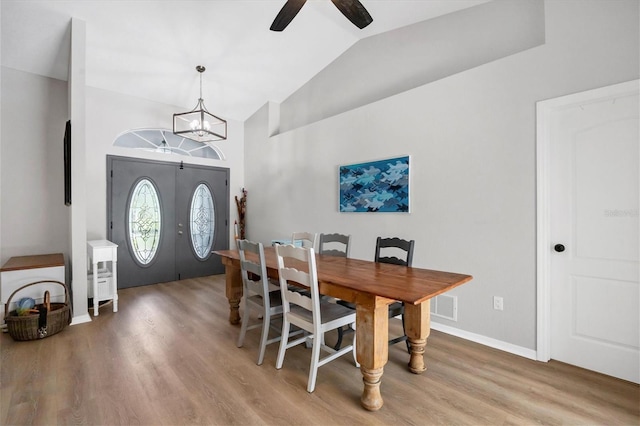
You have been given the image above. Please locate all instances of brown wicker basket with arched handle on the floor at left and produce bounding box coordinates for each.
[4,280,71,340]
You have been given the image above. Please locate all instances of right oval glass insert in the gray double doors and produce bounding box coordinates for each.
[189,183,215,260]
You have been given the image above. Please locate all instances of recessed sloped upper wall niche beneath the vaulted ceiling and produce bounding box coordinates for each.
[280,0,545,131]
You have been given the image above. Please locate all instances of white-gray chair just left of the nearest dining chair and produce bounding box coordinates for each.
[237,240,282,365]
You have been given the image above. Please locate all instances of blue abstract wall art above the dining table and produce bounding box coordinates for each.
[340,156,409,213]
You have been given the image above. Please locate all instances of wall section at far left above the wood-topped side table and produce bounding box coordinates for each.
[0,67,70,264]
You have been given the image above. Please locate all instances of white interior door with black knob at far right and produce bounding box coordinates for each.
[541,82,640,383]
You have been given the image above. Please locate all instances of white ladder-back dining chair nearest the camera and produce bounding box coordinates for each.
[276,245,357,393]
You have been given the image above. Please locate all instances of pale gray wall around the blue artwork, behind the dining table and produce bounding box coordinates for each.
[245,0,640,350]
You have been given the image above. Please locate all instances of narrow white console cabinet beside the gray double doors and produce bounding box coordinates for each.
[87,240,118,316]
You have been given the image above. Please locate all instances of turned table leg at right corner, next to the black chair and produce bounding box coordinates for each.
[404,300,431,374]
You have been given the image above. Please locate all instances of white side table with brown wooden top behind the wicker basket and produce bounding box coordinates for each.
[0,253,65,324]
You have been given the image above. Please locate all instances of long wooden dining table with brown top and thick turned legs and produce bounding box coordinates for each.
[214,247,473,411]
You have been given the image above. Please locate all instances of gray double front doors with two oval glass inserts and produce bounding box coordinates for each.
[107,156,229,288]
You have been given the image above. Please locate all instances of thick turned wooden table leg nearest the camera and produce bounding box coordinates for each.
[356,295,389,411]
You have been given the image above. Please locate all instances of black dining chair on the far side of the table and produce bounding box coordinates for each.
[334,237,415,352]
